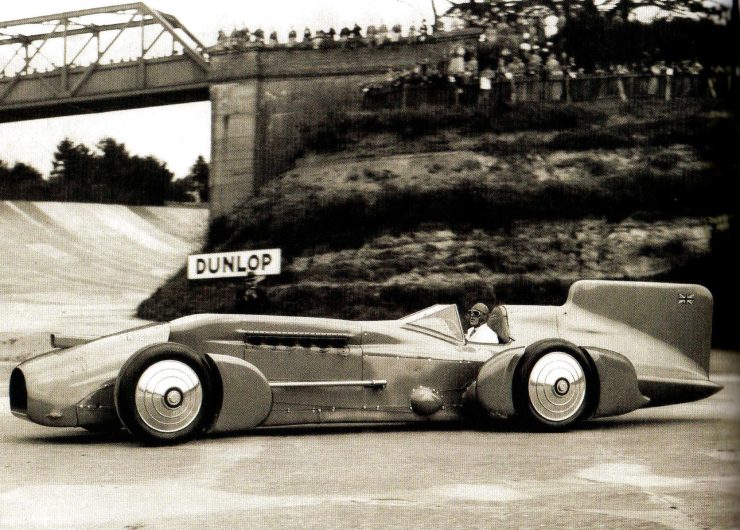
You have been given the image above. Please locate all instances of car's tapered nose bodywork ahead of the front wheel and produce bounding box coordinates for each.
[12,324,169,427]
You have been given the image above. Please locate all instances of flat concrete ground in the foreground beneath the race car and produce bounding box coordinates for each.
[0,352,740,529]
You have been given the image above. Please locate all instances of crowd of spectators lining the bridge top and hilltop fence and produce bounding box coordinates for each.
[216,10,737,101]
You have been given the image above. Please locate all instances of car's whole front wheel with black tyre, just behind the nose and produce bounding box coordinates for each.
[115,343,218,445]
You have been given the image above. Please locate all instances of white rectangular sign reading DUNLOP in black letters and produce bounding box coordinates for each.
[188,248,280,280]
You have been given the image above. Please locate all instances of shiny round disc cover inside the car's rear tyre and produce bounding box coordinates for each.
[527,352,586,422]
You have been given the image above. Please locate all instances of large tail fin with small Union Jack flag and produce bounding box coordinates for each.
[565,280,713,373]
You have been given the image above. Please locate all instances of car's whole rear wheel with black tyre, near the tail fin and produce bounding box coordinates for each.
[512,340,599,430]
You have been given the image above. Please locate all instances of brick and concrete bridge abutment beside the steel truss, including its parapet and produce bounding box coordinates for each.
[209,30,479,219]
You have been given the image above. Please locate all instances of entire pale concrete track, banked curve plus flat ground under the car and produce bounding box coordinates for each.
[0,202,740,529]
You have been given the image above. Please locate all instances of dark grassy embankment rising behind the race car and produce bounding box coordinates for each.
[138,99,740,346]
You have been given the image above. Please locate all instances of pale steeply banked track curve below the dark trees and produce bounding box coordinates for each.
[0,201,208,336]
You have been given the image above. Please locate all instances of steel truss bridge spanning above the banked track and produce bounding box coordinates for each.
[0,2,210,122]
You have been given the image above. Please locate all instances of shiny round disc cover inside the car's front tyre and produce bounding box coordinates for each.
[135,360,203,433]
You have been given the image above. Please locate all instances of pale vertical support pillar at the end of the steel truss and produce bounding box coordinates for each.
[209,79,260,219]
